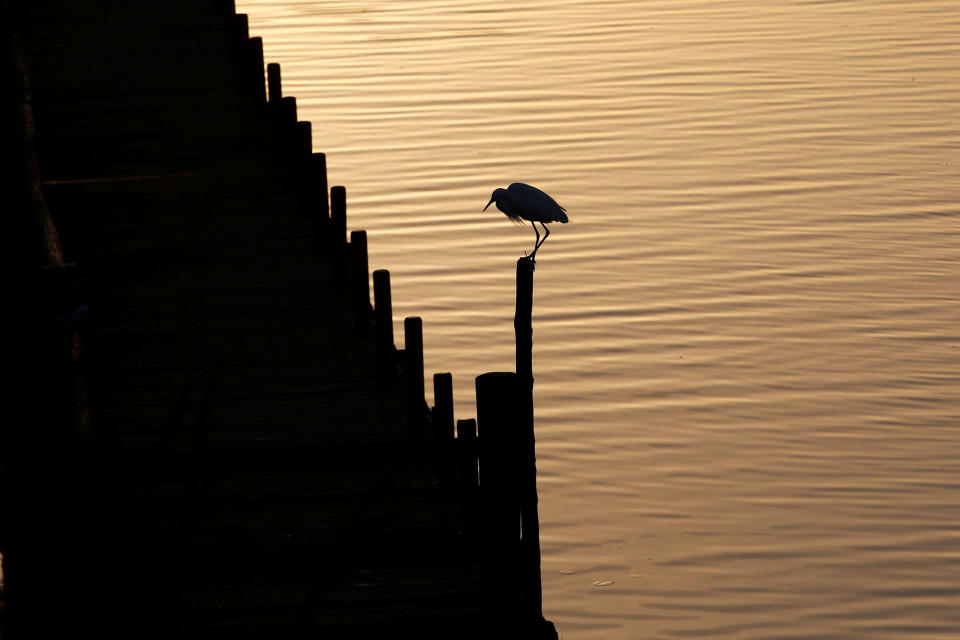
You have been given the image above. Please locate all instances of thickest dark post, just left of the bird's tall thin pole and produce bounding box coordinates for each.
[476,372,522,624]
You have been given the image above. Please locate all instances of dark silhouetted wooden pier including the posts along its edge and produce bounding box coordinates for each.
[0,0,556,640]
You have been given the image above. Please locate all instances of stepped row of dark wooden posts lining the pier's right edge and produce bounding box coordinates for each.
[231,14,556,638]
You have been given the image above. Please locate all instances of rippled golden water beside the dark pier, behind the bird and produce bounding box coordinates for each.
[238,0,960,640]
